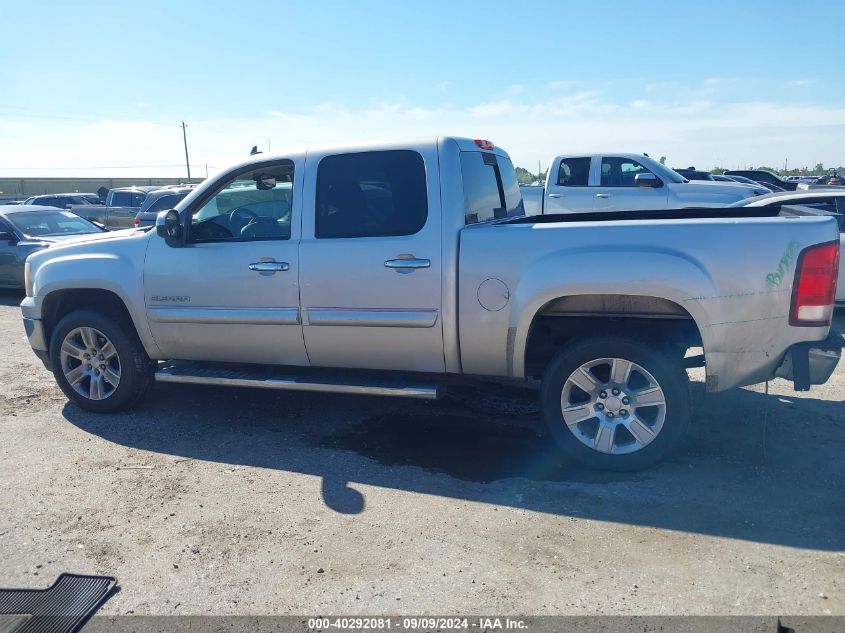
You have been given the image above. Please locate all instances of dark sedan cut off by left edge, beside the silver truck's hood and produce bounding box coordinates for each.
[0,205,104,290]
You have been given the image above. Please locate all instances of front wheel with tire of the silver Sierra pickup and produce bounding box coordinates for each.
[50,310,153,413]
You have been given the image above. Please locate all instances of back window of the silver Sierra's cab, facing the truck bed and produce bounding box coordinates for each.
[461,152,525,224]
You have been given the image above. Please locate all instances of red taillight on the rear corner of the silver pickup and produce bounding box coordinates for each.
[789,242,839,326]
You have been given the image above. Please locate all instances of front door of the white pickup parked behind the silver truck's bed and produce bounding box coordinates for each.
[593,156,668,211]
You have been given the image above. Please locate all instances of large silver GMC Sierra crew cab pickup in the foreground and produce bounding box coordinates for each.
[16,138,842,469]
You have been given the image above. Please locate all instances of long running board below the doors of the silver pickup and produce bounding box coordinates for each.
[155,362,445,400]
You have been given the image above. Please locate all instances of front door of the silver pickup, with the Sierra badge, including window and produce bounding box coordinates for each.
[144,160,308,365]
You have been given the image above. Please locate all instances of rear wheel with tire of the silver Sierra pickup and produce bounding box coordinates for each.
[540,337,690,471]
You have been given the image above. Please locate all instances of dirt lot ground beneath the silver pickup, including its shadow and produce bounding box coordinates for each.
[0,294,845,615]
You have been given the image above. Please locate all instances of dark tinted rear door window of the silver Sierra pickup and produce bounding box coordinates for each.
[316,150,428,238]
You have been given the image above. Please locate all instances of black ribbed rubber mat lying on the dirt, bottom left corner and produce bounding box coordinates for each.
[0,574,117,633]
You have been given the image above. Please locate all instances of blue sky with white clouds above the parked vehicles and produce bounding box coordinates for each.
[0,0,845,176]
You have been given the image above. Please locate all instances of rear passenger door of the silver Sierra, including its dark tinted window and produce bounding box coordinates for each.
[300,145,445,372]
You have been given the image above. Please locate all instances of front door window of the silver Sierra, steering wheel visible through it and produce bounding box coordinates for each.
[189,161,293,242]
